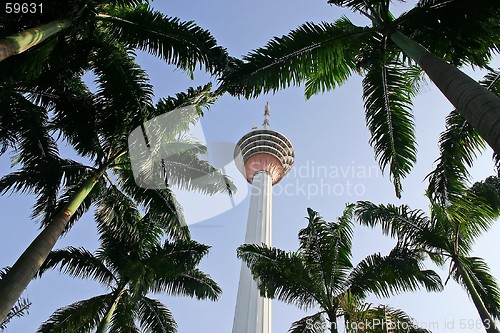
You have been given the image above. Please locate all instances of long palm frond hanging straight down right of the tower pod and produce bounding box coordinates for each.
[363,61,417,198]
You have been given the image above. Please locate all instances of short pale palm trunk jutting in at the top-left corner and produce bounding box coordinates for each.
[0,20,71,61]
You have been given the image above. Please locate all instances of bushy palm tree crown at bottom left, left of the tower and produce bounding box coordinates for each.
[37,190,221,333]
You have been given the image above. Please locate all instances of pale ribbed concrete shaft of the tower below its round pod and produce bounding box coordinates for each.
[232,171,273,333]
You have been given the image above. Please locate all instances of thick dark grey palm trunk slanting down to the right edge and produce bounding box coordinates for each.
[391,32,500,154]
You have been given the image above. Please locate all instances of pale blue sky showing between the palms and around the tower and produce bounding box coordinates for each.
[0,0,500,333]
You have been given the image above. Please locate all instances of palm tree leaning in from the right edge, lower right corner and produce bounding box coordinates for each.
[356,177,500,333]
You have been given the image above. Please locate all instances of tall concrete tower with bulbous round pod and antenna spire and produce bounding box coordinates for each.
[232,104,294,333]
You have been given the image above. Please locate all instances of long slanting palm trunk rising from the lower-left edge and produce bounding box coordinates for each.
[0,165,107,322]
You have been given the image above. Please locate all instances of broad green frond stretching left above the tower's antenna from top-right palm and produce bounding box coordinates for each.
[223,17,370,97]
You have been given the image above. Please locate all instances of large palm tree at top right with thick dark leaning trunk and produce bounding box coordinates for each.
[223,0,500,197]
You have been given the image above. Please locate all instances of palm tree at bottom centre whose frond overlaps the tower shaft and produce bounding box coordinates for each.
[238,205,442,332]
